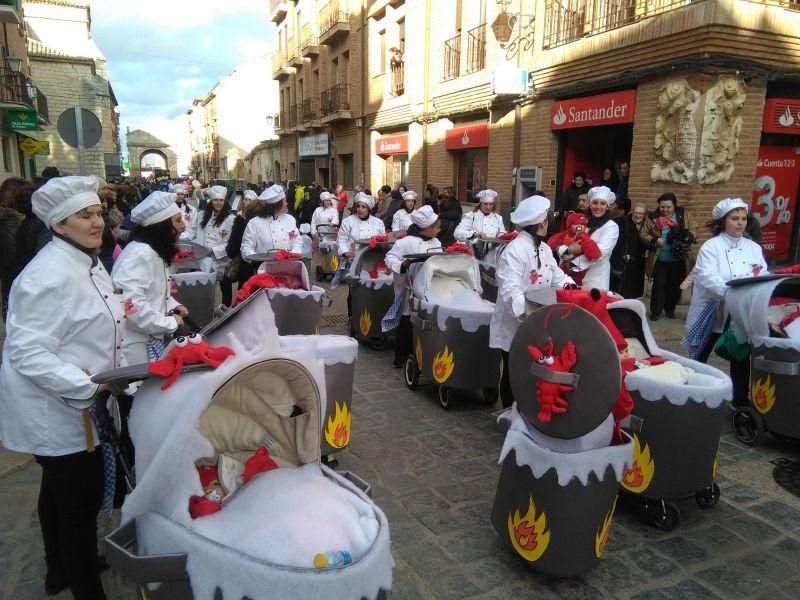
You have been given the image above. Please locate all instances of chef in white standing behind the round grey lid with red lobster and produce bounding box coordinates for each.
[489,196,575,408]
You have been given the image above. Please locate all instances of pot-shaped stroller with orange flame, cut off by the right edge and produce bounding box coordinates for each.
[725,274,800,445]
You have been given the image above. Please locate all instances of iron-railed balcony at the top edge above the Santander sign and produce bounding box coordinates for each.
[543,0,800,48]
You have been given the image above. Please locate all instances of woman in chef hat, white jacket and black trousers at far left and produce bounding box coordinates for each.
[0,177,127,600]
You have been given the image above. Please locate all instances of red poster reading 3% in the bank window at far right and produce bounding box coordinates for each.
[752,146,800,261]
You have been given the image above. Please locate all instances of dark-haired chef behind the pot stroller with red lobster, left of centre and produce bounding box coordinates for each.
[242,185,303,260]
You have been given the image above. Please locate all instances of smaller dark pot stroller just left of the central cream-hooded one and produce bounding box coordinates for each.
[347,243,394,342]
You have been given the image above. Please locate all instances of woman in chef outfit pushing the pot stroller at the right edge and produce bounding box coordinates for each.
[682,198,767,406]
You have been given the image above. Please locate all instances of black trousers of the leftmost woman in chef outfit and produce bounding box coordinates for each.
[34,448,106,600]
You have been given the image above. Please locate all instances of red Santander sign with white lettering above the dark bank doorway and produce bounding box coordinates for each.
[550,90,636,131]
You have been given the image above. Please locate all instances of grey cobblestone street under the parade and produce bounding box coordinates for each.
[0,285,800,600]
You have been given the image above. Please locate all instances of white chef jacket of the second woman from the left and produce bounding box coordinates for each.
[111,242,179,365]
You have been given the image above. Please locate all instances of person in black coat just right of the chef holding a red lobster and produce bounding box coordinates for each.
[611,205,647,298]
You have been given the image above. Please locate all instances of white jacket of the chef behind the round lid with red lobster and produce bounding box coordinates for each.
[489,231,575,352]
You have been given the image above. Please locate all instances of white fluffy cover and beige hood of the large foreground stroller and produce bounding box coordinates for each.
[117,293,393,600]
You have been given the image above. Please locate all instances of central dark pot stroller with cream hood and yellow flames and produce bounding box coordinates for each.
[404,252,501,409]
